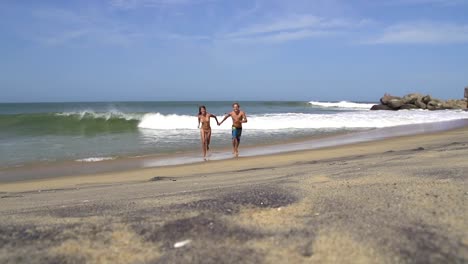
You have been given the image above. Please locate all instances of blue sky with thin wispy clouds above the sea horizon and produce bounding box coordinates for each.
[0,0,468,102]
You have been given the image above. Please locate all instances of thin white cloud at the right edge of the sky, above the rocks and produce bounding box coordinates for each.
[366,22,468,44]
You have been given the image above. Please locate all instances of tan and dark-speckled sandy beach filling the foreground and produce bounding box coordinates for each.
[0,127,468,263]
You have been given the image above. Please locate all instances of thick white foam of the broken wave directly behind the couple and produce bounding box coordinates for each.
[138,110,468,130]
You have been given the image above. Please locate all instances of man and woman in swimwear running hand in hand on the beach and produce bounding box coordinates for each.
[198,103,247,160]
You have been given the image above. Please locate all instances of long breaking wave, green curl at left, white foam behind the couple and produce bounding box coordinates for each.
[0,108,468,135]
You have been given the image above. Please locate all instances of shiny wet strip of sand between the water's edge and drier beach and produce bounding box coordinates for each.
[0,119,468,186]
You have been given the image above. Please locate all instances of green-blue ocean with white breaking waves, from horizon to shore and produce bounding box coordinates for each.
[0,101,468,168]
